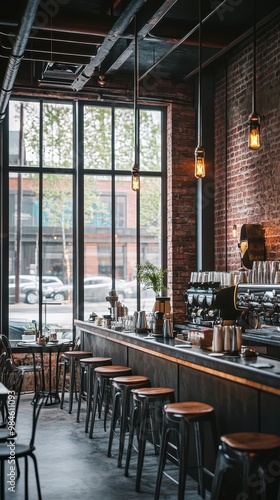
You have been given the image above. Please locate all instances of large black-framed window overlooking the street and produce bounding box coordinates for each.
[3,100,166,338]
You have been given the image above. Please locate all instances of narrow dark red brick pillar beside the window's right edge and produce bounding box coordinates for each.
[167,97,196,323]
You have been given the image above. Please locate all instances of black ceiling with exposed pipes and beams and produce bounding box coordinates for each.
[0,0,280,102]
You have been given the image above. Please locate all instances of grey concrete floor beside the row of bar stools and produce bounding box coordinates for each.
[2,394,210,500]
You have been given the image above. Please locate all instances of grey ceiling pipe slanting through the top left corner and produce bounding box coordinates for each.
[0,0,40,122]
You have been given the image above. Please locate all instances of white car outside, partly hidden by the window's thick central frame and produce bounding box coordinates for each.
[47,276,132,302]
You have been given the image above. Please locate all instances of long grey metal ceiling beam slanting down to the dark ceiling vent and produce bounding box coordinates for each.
[72,0,146,90]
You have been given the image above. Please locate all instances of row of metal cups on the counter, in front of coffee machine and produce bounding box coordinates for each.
[212,325,242,354]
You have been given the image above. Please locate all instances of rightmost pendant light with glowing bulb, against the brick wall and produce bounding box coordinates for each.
[248,0,261,149]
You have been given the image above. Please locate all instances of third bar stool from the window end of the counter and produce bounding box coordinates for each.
[89,365,132,439]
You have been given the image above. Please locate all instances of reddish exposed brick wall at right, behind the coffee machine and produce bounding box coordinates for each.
[215,22,280,270]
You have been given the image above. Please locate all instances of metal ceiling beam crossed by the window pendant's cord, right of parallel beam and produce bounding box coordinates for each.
[102,0,177,74]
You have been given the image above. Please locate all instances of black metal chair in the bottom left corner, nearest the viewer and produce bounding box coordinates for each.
[0,393,45,500]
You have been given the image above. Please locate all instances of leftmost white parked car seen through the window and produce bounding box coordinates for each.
[9,274,63,304]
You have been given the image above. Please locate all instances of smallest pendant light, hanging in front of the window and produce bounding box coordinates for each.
[131,16,140,191]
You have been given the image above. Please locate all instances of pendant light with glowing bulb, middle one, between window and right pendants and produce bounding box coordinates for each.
[194,0,205,179]
